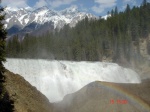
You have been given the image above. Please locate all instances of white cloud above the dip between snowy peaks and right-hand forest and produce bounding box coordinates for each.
[92,0,117,13]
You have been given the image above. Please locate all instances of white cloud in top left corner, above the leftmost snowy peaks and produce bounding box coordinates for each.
[2,0,28,8]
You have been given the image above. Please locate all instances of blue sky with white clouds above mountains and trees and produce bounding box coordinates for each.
[2,0,150,16]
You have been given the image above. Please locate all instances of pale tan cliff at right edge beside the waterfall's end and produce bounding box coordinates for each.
[131,35,150,79]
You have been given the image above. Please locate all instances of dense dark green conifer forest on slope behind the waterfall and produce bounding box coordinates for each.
[7,0,150,62]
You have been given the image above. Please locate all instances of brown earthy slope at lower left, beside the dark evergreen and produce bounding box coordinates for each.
[5,71,53,112]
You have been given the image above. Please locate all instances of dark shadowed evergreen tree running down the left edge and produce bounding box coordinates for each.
[0,0,13,112]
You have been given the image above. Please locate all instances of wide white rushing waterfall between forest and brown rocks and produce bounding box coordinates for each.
[4,59,141,102]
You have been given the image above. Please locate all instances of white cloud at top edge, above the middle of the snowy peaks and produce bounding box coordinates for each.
[35,0,76,8]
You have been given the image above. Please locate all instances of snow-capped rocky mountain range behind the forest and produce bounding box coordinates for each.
[5,6,97,34]
